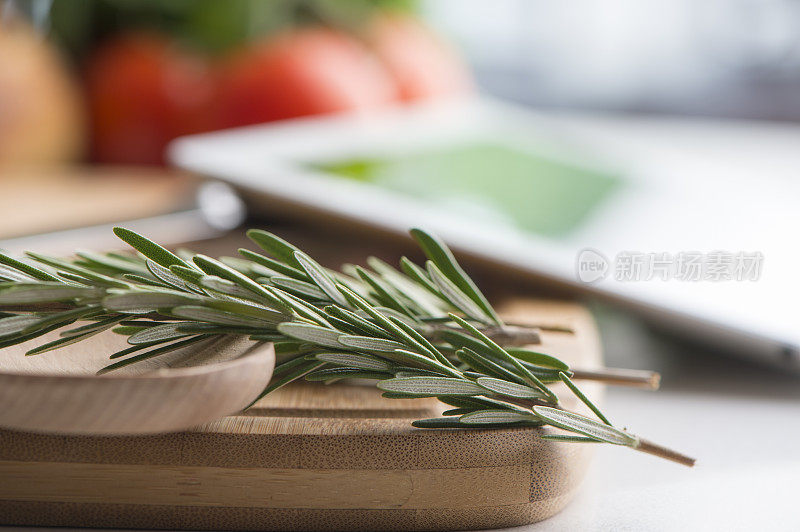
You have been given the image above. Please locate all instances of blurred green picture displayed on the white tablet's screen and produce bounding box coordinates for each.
[312,143,622,238]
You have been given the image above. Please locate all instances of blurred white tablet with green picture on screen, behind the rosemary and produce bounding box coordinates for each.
[170,98,800,369]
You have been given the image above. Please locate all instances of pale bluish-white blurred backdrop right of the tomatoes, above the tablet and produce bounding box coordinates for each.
[432,0,800,120]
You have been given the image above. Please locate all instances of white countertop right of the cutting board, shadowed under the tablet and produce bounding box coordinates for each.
[510,311,800,532]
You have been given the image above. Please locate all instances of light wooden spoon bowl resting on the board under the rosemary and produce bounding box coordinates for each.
[0,332,275,435]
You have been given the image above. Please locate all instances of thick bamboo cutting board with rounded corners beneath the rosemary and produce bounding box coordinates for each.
[0,301,602,530]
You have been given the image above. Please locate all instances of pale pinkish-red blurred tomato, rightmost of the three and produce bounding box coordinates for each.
[367,13,472,101]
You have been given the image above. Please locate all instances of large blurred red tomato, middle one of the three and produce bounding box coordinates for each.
[218,28,396,127]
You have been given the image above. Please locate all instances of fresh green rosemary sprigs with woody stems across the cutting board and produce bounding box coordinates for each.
[0,228,694,465]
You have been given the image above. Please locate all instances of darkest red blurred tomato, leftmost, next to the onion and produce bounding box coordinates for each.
[87,34,215,164]
